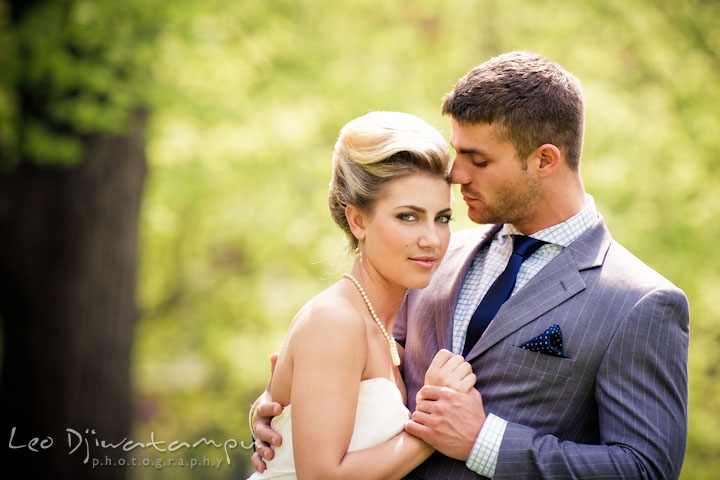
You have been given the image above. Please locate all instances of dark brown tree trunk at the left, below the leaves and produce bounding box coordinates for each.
[0,109,147,479]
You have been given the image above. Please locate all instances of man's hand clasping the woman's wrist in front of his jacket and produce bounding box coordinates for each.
[405,385,486,461]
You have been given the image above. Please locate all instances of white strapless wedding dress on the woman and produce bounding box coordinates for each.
[248,377,410,480]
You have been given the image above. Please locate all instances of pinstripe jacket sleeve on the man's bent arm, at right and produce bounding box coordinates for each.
[495,288,689,479]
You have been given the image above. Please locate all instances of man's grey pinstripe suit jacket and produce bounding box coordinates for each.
[395,220,689,479]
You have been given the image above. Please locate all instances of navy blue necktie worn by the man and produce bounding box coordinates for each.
[463,235,546,356]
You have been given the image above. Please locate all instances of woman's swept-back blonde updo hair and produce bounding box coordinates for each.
[328,112,450,248]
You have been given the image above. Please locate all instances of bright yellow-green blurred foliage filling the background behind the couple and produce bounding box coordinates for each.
[0,0,720,479]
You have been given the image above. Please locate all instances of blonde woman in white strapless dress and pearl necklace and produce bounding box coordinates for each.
[250,112,475,480]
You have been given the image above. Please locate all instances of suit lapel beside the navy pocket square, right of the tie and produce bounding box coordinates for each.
[466,218,612,361]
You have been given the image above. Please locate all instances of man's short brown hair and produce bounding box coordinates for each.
[443,52,585,168]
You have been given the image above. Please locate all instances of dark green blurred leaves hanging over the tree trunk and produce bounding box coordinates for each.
[0,0,161,168]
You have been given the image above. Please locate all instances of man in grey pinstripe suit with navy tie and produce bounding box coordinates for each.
[253,52,689,479]
